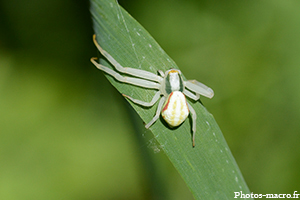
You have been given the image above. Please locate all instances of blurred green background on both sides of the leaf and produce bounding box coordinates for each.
[0,0,300,200]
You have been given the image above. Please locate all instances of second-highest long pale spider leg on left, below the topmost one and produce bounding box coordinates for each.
[91,58,160,89]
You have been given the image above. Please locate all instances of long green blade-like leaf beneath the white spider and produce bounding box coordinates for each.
[91,0,250,199]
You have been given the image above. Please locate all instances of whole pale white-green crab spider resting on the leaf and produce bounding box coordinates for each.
[91,34,214,147]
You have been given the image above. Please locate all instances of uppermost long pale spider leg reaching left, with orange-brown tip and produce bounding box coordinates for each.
[93,34,163,82]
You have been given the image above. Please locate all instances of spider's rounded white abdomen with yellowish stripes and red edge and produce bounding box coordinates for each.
[161,91,189,127]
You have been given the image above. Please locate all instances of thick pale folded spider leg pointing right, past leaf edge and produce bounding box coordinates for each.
[184,80,214,98]
